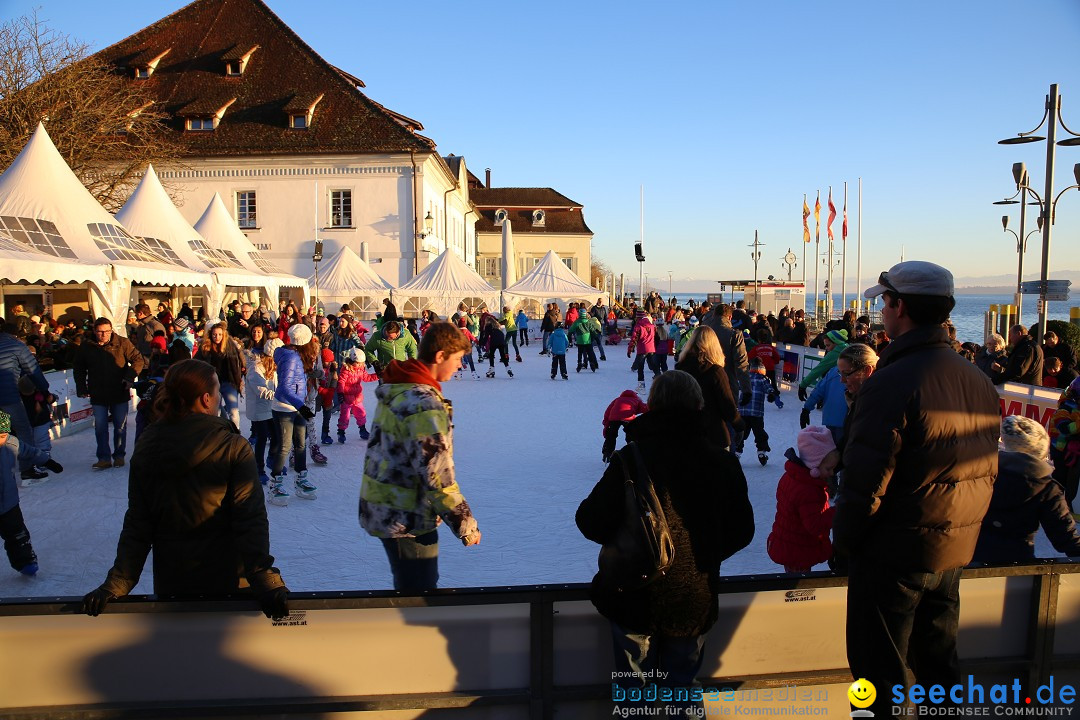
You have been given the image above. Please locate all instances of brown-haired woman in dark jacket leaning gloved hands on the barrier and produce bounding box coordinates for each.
[83,361,288,619]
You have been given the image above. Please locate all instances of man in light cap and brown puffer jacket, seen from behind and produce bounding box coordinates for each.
[833,260,999,718]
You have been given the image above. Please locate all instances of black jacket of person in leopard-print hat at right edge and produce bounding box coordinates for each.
[973,452,1080,562]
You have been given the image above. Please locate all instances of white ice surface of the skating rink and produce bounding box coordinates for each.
[0,342,1056,598]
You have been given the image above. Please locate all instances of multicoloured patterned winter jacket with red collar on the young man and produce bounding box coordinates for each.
[360,359,477,542]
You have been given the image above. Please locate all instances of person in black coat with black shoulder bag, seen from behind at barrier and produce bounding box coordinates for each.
[577,370,754,707]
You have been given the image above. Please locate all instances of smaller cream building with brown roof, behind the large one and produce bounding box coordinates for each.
[467,180,593,287]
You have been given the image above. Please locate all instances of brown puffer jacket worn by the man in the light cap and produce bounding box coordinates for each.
[833,326,1000,572]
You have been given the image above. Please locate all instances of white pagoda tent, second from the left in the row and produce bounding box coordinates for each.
[117,165,278,311]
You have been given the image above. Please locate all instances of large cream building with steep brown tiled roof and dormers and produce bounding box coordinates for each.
[97,0,476,302]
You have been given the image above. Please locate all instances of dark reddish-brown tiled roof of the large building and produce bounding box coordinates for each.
[89,0,435,157]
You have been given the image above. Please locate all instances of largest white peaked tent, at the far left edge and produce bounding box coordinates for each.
[0,123,208,327]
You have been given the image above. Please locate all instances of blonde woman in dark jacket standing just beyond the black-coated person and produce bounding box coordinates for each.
[675,325,743,448]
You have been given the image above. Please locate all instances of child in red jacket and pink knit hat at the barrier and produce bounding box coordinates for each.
[766,425,840,572]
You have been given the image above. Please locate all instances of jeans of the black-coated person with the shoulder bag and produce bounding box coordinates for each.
[611,623,704,717]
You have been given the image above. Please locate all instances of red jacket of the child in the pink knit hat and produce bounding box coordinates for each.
[766,450,836,568]
